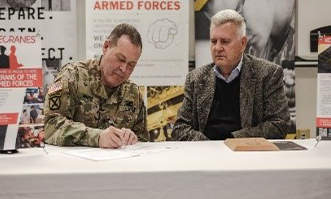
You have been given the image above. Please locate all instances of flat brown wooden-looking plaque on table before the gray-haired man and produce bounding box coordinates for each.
[224,138,279,151]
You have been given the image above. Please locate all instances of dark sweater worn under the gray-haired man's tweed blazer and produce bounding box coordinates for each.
[203,75,241,140]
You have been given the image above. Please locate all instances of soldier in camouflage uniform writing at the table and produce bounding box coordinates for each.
[44,24,148,148]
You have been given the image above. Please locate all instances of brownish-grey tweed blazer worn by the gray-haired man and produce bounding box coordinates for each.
[172,55,290,140]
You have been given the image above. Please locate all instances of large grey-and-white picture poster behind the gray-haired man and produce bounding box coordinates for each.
[194,0,296,134]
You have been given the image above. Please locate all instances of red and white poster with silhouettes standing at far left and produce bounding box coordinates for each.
[0,31,44,151]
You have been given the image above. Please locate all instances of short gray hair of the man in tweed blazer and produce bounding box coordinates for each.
[211,9,246,37]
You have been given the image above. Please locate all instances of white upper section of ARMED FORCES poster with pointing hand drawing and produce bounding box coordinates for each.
[86,0,189,86]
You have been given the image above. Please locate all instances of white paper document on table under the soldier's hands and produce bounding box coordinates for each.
[64,143,174,161]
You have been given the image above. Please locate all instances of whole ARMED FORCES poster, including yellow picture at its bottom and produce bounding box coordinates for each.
[86,0,190,141]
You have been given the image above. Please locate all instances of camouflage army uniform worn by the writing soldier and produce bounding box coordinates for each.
[44,58,148,147]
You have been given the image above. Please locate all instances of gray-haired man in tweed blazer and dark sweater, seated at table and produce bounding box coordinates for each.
[172,10,290,140]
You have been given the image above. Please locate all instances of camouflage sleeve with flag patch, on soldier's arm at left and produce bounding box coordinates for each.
[44,66,102,147]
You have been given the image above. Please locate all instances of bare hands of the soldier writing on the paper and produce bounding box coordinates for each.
[99,126,138,149]
